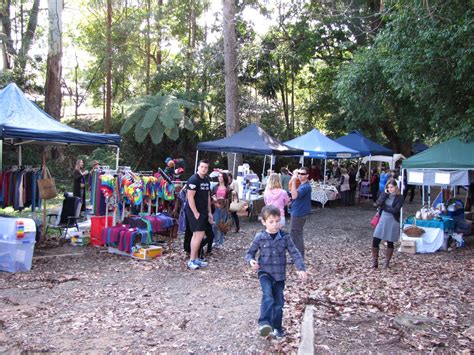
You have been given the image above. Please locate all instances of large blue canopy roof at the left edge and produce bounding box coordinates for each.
[0,84,120,146]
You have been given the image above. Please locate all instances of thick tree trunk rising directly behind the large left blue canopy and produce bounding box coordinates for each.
[45,0,63,121]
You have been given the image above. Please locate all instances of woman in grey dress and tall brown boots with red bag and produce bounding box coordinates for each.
[372,179,404,269]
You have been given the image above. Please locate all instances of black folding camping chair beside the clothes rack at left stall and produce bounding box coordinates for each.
[45,192,82,237]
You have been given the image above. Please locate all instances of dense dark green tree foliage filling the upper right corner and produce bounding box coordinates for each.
[335,1,474,148]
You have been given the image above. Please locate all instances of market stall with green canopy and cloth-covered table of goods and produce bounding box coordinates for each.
[400,138,474,252]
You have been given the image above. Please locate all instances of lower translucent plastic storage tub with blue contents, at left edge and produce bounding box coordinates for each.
[0,240,35,272]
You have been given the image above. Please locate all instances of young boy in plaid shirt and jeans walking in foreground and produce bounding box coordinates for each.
[245,205,306,338]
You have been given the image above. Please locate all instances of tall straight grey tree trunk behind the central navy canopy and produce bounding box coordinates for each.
[223,0,240,174]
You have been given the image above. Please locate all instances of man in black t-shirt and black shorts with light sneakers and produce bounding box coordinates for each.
[185,160,213,270]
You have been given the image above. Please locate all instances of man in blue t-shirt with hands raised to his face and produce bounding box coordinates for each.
[290,166,311,258]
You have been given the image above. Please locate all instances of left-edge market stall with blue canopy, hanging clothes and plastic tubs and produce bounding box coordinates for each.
[0,83,121,271]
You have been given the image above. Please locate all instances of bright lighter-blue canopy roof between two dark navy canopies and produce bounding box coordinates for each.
[285,128,359,159]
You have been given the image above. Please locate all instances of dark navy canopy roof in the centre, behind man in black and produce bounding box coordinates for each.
[197,124,303,155]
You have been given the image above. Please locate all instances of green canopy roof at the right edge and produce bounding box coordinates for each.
[402,138,474,169]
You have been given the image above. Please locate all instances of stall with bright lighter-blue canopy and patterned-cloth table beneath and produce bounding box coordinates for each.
[285,128,360,207]
